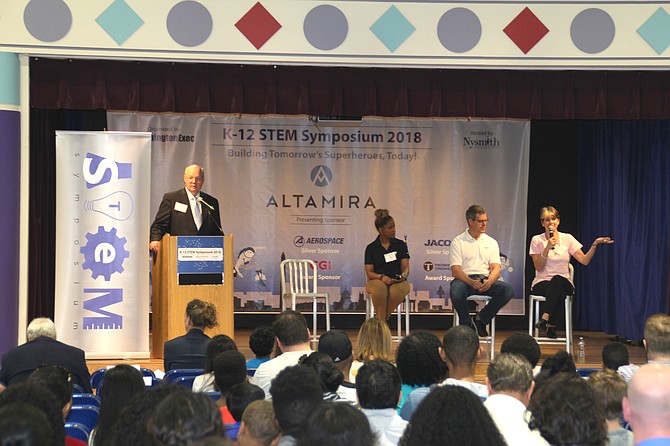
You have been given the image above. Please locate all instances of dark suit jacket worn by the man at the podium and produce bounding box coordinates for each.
[151,187,223,242]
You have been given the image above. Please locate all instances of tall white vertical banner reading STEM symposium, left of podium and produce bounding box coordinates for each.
[55,131,151,358]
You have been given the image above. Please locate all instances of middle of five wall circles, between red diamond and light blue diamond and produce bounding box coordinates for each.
[302,5,349,51]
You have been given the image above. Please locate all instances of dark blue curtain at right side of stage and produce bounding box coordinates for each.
[576,121,670,340]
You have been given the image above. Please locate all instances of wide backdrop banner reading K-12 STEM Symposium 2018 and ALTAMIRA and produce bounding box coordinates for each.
[108,112,530,314]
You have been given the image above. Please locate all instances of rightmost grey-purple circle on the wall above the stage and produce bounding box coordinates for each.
[570,8,615,54]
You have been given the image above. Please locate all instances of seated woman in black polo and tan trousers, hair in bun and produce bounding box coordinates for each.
[365,209,409,321]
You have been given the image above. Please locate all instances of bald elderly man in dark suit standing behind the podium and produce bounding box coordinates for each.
[149,164,223,252]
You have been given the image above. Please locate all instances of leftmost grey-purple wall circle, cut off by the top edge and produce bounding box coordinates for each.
[23,0,72,42]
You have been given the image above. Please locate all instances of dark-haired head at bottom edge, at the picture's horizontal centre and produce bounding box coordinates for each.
[298,402,376,446]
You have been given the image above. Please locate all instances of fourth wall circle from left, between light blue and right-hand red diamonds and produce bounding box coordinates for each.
[437,8,482,53]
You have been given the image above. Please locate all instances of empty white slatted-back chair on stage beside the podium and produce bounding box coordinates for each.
[280,259,330,342]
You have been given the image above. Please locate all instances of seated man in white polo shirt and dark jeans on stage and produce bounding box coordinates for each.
[449,204,514,337]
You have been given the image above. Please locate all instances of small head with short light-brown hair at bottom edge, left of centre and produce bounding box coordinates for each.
[237,400,280,446]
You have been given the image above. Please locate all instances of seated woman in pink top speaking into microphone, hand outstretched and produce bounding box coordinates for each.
[529,206,614,339]
